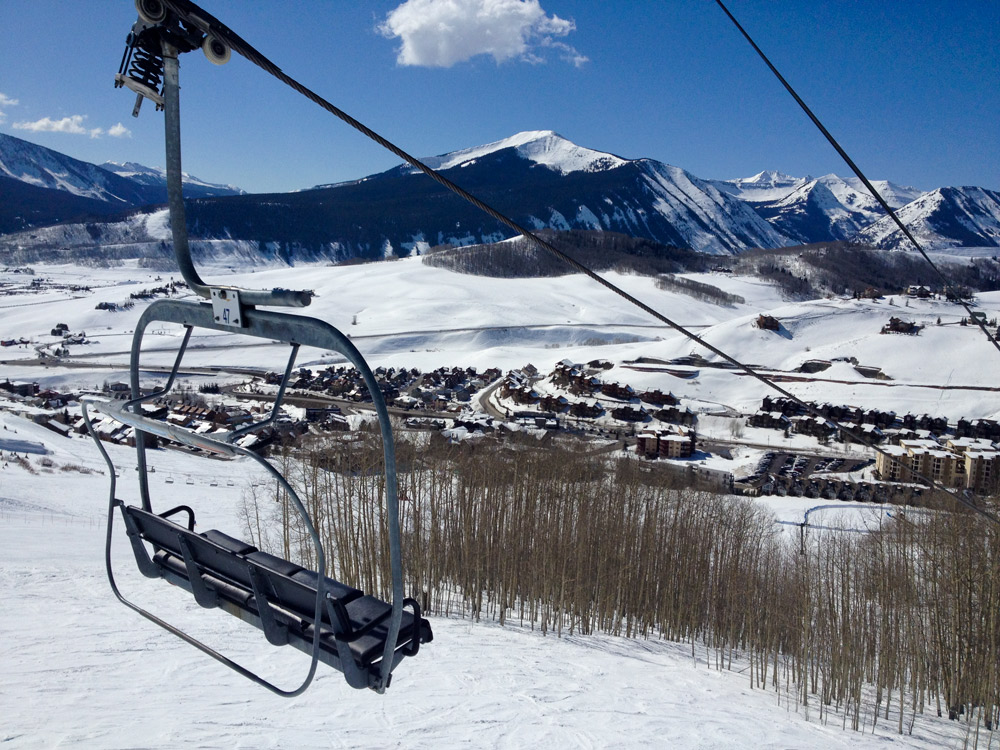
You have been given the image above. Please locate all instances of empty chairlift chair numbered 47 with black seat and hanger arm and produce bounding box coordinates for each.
[82,0,433,697]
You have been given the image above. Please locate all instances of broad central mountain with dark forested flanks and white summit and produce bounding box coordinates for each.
[178,131,793,258]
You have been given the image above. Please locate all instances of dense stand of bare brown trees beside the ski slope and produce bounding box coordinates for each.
[244,436,1000,747]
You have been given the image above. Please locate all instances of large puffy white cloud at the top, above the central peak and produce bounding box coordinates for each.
[378,0,587,68]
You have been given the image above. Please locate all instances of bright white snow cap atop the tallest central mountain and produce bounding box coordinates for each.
[414,130,627,174]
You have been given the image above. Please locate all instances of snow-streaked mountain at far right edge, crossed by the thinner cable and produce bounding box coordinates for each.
[858,187,1000,249]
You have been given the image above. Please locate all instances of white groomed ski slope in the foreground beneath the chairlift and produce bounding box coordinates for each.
[0,414,980,750]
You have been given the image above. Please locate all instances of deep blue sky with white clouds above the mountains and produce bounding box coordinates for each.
[0,0,1000,192]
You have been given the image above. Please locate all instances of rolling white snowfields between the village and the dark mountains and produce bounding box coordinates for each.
[0,258,1000,421]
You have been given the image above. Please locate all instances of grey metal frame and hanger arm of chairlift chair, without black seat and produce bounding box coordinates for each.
[82,0,412,697]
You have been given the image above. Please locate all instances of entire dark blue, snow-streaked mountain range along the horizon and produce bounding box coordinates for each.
[0,131,1000,262]
